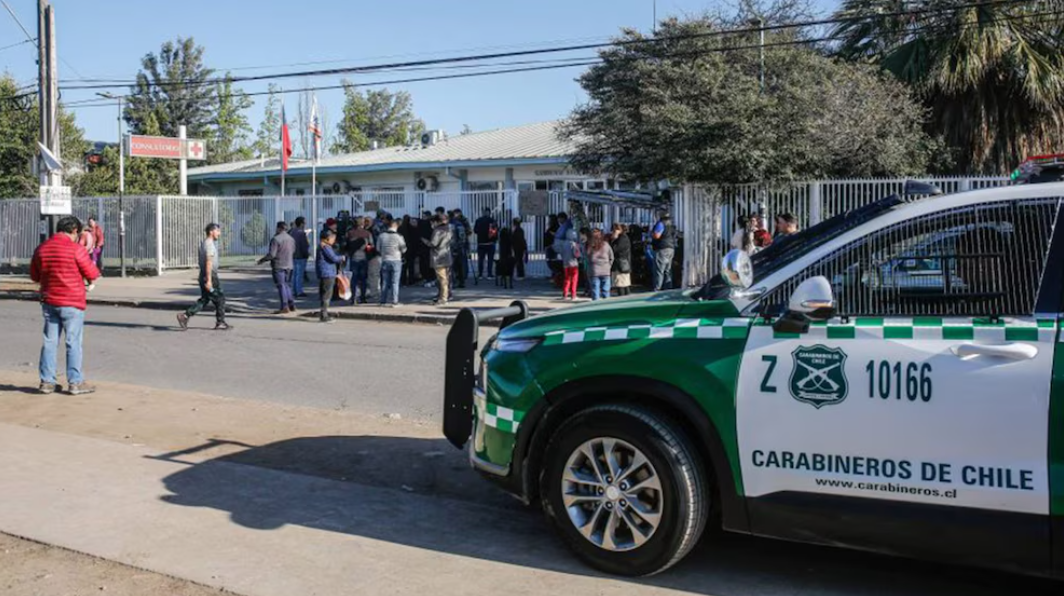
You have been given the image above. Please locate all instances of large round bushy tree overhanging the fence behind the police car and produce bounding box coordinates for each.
[559,17,933,184]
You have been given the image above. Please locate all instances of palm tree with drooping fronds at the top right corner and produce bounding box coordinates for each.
[832,0,1064,175]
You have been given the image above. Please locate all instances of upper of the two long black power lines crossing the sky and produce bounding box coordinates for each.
[45,0,1030,90]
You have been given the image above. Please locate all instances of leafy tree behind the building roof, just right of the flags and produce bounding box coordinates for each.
[332,82,425,153]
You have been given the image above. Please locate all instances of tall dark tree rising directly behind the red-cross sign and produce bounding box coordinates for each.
[124,37,218,137]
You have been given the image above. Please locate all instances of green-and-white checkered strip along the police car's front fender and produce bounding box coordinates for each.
[543,317,751,346]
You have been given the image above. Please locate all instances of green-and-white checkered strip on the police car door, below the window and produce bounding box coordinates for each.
[772,317,1057,342]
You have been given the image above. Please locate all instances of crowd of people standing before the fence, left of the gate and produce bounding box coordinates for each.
[231,208,529,327]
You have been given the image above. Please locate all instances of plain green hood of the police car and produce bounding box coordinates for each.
[500,289,734,338]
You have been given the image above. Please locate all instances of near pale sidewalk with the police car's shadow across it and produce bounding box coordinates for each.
[0,371,683,596]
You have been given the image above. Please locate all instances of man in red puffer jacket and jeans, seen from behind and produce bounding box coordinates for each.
[30,216,100,395]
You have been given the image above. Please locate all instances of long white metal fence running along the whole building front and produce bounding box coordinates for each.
[0,178,1008,285]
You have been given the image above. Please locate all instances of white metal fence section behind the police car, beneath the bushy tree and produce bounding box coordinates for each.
[678,177,1009,285]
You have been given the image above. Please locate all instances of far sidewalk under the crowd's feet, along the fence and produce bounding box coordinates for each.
[0,265,583,325]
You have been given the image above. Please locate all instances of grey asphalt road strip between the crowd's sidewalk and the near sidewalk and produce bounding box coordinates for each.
[0,300,486,419]
